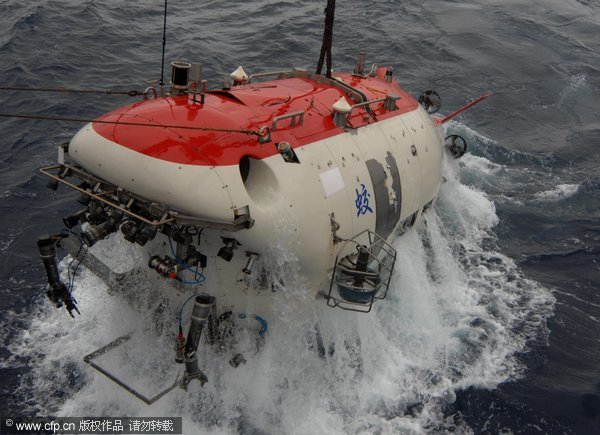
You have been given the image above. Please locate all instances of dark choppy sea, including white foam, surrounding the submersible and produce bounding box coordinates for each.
[0,0,600,434]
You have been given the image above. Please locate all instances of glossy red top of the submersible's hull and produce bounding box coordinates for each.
[93,68,418,166]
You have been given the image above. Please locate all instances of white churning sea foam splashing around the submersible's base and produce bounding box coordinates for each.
[9,152,553,434]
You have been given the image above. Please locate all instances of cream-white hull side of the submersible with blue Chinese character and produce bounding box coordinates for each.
[69,107,443,312]
